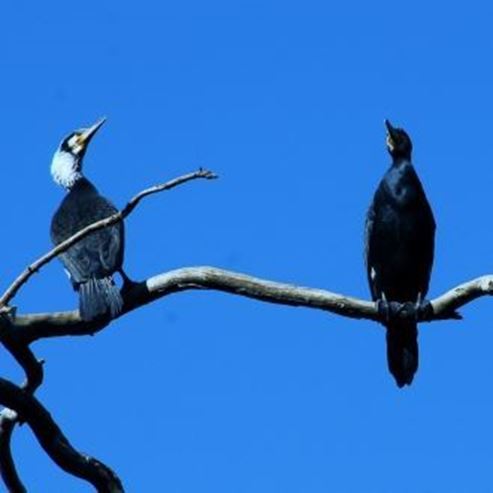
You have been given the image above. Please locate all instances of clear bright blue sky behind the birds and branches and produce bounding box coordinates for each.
[0,0,493,493]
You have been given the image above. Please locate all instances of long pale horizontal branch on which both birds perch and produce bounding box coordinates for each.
[9,267,493,344]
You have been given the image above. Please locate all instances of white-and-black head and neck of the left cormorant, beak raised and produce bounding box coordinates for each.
[51,118,106,189]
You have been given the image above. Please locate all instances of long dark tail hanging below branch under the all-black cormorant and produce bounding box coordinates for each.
[387,321,418,387]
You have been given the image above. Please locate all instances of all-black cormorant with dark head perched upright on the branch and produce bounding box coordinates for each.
[365,120,436,387]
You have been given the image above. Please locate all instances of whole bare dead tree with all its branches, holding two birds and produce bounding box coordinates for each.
[0,169,493,493]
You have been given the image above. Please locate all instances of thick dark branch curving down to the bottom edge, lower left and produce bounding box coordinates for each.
[0,378,123,493]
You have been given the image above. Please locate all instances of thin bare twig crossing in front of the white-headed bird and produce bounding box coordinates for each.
[0,168,217,307]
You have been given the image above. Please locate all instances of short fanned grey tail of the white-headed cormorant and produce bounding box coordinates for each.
[79,277,123,322]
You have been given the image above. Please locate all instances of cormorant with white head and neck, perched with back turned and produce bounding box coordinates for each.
[50,118,127,321]
